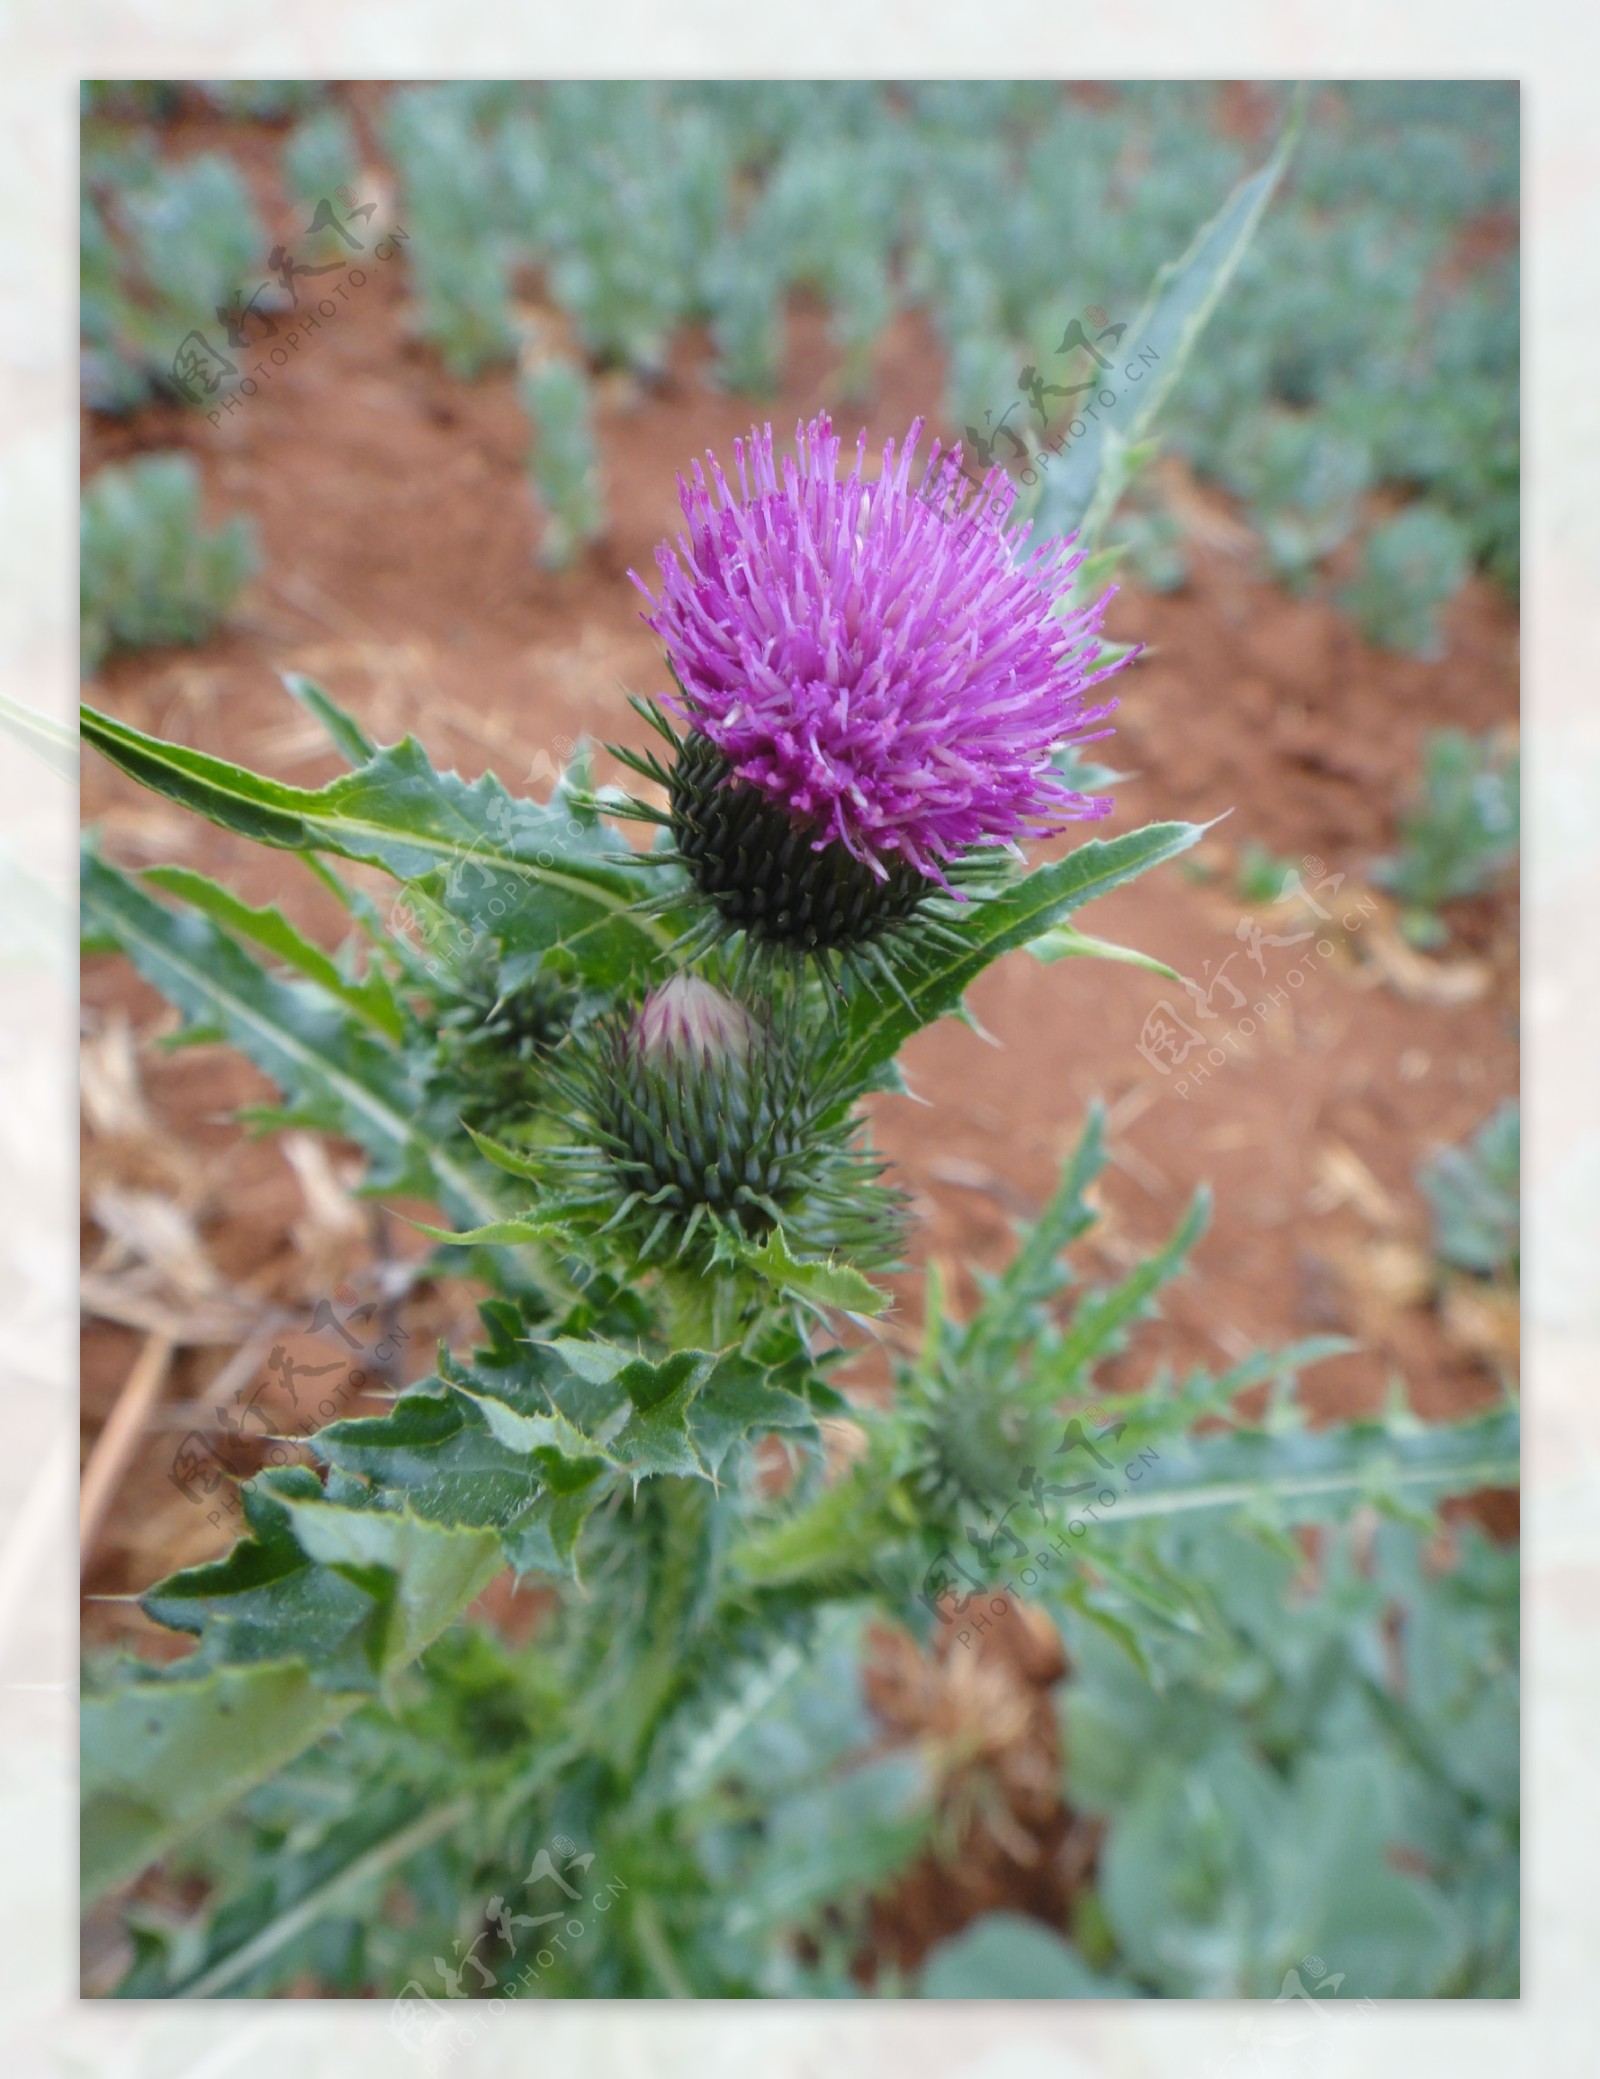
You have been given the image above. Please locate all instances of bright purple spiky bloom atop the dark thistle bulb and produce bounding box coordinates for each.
[630,416,1126,888]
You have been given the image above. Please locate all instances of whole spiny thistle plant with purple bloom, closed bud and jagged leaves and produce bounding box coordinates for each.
[81,109,1515,1998]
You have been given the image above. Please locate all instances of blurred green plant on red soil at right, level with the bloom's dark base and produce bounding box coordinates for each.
[1371,730,1521,948]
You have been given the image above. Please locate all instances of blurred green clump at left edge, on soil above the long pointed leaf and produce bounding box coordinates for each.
[79,455,258,676]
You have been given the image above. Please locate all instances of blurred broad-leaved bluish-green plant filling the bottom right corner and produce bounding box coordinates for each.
[921,1511,1519,2004]
